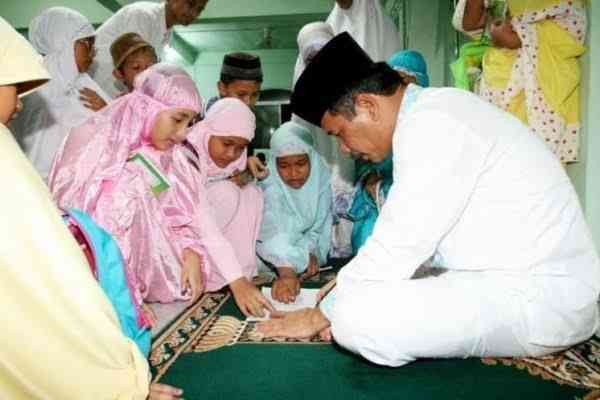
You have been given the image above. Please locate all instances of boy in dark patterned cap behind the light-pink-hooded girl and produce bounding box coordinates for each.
[205,52,263,114]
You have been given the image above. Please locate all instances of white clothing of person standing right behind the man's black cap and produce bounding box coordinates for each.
[327,0,402,62]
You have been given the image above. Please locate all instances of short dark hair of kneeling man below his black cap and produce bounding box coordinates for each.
[327,62,408,120]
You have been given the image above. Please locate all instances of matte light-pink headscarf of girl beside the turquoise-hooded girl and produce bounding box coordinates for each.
[188,97,256,178]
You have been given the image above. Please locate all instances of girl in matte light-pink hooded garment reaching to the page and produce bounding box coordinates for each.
[188,98,272,316]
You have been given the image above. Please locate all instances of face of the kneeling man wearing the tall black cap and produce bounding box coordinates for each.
[321,100,392,162]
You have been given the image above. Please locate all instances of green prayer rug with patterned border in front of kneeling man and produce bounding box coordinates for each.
[150,274,600,400]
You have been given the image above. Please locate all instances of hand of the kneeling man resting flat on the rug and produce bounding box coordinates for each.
[256,308,330,339]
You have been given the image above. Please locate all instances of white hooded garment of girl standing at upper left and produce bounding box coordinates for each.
[13,7,109,180]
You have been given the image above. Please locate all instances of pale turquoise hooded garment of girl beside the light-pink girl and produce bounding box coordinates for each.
[257,122,332,273]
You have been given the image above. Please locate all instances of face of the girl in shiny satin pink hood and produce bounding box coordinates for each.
[150,108,196,151]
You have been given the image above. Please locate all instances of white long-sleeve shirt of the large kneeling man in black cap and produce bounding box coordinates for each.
[321,86,600,346]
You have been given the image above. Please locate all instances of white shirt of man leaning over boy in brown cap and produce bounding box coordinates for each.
[91,1,171,97]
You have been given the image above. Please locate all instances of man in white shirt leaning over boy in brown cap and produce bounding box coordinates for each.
[91,0,208,97]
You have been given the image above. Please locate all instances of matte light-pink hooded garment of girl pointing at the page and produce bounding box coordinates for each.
[188,98,263,290]
